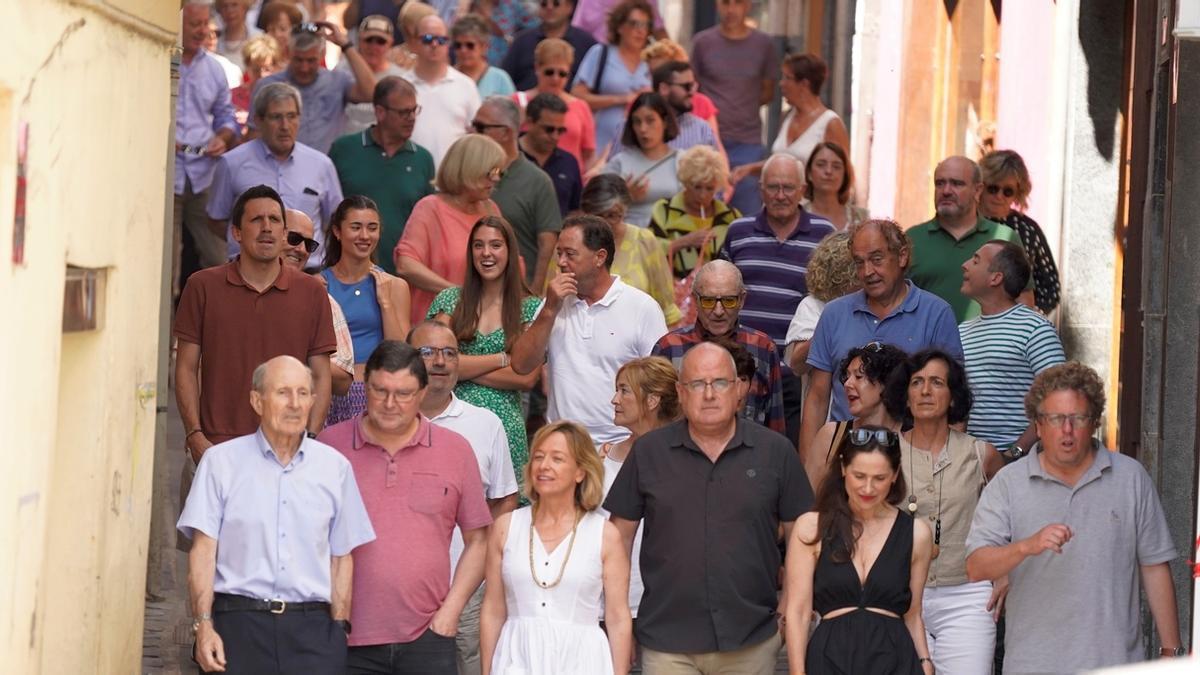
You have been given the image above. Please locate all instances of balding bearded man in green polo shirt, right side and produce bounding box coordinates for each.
[908,156,1021,323]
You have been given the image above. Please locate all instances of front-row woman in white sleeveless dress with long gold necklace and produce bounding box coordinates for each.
[480,422,632,675]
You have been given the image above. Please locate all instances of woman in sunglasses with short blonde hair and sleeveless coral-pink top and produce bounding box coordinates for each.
[512,37,596,174]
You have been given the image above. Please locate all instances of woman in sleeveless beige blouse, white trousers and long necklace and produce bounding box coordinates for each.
[884,350,1008,673]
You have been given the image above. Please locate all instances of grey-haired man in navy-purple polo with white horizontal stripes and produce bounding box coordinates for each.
[719,153,833,440]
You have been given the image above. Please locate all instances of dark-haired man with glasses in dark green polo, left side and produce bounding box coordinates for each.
[329,76,433,274]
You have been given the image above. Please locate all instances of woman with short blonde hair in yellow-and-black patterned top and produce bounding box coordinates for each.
[650,145,742,279]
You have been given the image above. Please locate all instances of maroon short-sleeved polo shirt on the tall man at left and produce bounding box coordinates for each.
[170,261,337,443]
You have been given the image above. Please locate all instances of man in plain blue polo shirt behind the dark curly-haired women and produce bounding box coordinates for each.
[800,220,962,460]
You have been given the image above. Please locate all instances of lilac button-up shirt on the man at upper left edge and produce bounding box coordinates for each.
[175,49,238,195]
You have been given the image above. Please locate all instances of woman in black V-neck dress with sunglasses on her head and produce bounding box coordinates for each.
[784,426,934,675]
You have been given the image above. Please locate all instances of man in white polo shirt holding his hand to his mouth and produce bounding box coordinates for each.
[511,215,667,444]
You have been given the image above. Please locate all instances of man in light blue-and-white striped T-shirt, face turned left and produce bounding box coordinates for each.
[959,239,1067,459]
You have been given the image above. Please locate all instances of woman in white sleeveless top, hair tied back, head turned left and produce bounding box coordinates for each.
[730,54,850,185]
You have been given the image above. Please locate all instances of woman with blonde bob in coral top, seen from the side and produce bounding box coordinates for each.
[394,133,508,325]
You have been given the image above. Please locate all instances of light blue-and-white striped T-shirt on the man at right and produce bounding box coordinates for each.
[959,305,1067,450]
